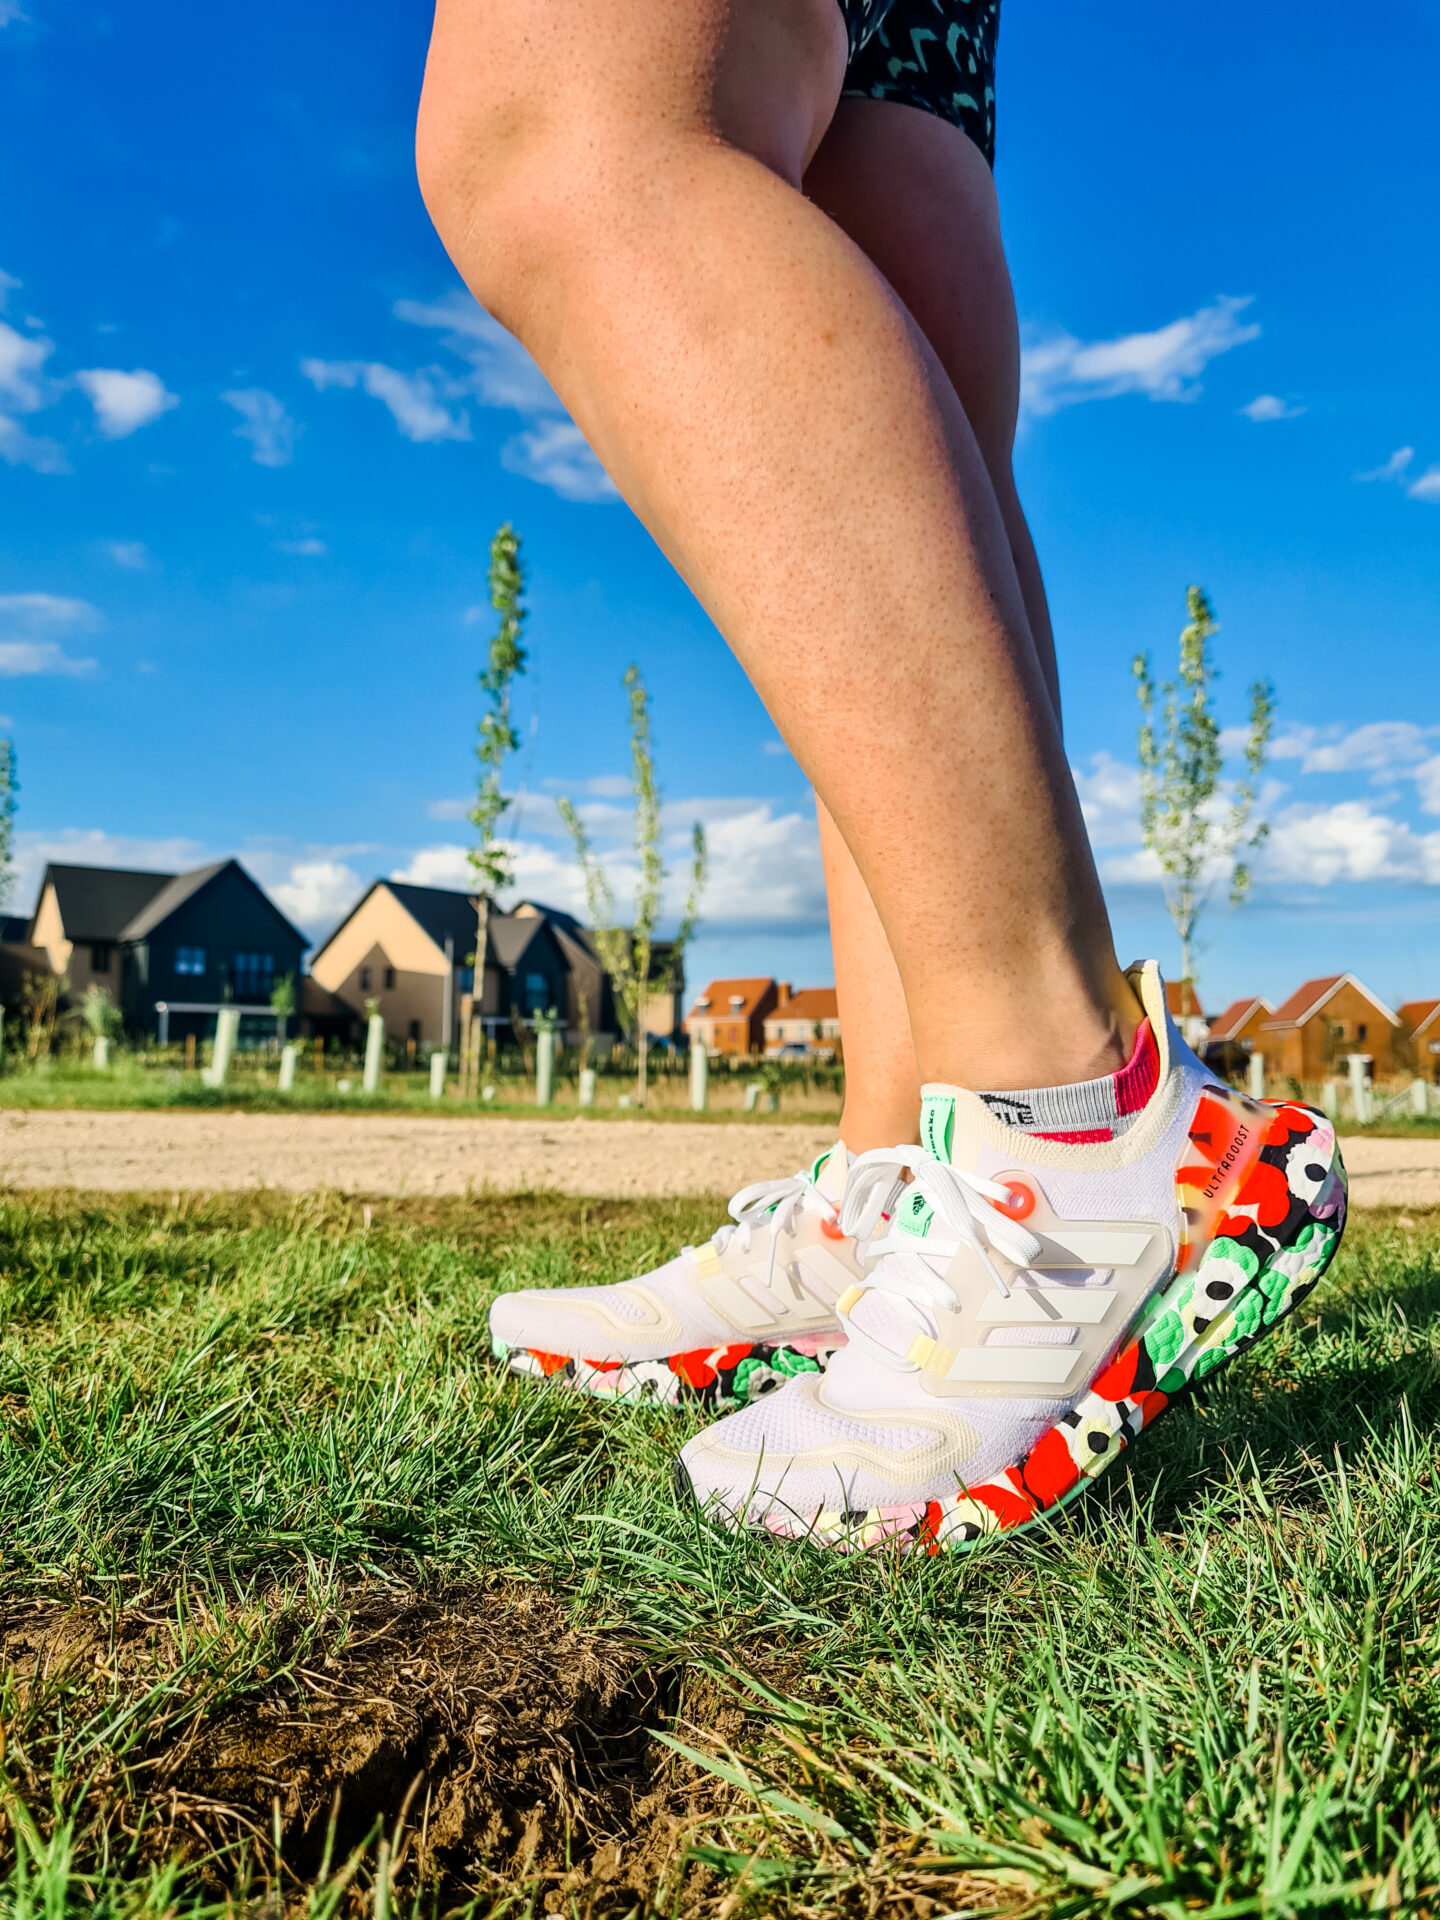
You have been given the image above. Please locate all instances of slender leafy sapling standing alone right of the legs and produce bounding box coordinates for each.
[1133,588,1275,1014]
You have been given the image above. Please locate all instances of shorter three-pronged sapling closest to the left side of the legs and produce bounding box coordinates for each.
[559,666,708,1106]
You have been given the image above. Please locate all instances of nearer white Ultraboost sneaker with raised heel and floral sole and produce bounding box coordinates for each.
[678,964,1346,1553]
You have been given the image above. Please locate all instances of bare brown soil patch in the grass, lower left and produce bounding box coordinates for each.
[0,1586,714,1912]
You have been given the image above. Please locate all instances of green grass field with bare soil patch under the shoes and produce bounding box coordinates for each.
[0,1194,1440,1920]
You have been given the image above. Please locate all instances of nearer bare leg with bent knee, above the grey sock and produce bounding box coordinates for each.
[420,0,1137,1087]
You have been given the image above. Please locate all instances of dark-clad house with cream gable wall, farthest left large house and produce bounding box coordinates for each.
[31,860,307,1039]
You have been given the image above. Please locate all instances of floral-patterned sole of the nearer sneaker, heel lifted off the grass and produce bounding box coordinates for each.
[695,1104,1348,1553]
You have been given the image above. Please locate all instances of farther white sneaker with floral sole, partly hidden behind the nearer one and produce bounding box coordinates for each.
[490,1144,864,1405]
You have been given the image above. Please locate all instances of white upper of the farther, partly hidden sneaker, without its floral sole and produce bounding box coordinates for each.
[490,1144,864,1363]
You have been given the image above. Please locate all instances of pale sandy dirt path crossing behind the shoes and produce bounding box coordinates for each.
[0,1110,1440,1206]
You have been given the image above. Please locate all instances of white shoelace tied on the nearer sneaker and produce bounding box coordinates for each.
[839,1146,1041,1373]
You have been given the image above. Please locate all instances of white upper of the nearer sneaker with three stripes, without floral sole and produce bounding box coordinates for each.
[682,966,1215,1519]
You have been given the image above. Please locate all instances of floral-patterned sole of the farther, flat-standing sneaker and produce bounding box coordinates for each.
[492,1329,845,1409]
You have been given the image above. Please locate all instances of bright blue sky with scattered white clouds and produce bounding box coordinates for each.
[0,0,1440,1000]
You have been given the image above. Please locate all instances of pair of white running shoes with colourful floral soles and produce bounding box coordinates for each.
[490,962,1346,1553]
